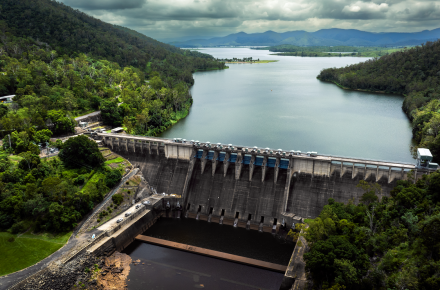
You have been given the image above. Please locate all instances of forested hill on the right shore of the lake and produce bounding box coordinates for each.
[318,40,440,162]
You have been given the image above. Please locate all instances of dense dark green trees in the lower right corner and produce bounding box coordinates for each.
[304,172,440,290]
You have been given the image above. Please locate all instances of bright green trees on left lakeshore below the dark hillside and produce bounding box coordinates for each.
[0,16,215,136]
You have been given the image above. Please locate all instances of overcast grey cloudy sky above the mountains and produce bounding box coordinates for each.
[61,0,440,40]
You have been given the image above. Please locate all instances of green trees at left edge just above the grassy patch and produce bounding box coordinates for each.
[0,151,109,233]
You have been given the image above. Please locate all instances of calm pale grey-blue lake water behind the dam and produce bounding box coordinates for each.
[162,48,414,162]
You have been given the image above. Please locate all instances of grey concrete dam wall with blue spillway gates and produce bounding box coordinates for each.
[94,133,431,230]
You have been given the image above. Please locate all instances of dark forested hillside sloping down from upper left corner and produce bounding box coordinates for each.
[0,0,224,84]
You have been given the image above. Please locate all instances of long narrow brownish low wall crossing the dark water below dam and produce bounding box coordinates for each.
[136,235,287,273]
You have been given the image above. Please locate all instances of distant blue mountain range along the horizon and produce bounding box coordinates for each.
[169,28,440,47]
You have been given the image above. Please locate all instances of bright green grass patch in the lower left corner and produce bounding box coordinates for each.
[0,232,72,276]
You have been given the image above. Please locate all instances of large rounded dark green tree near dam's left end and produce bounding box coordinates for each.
[59,135,104,168]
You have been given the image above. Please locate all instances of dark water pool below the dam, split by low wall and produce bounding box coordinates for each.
[124,218,288,290]
